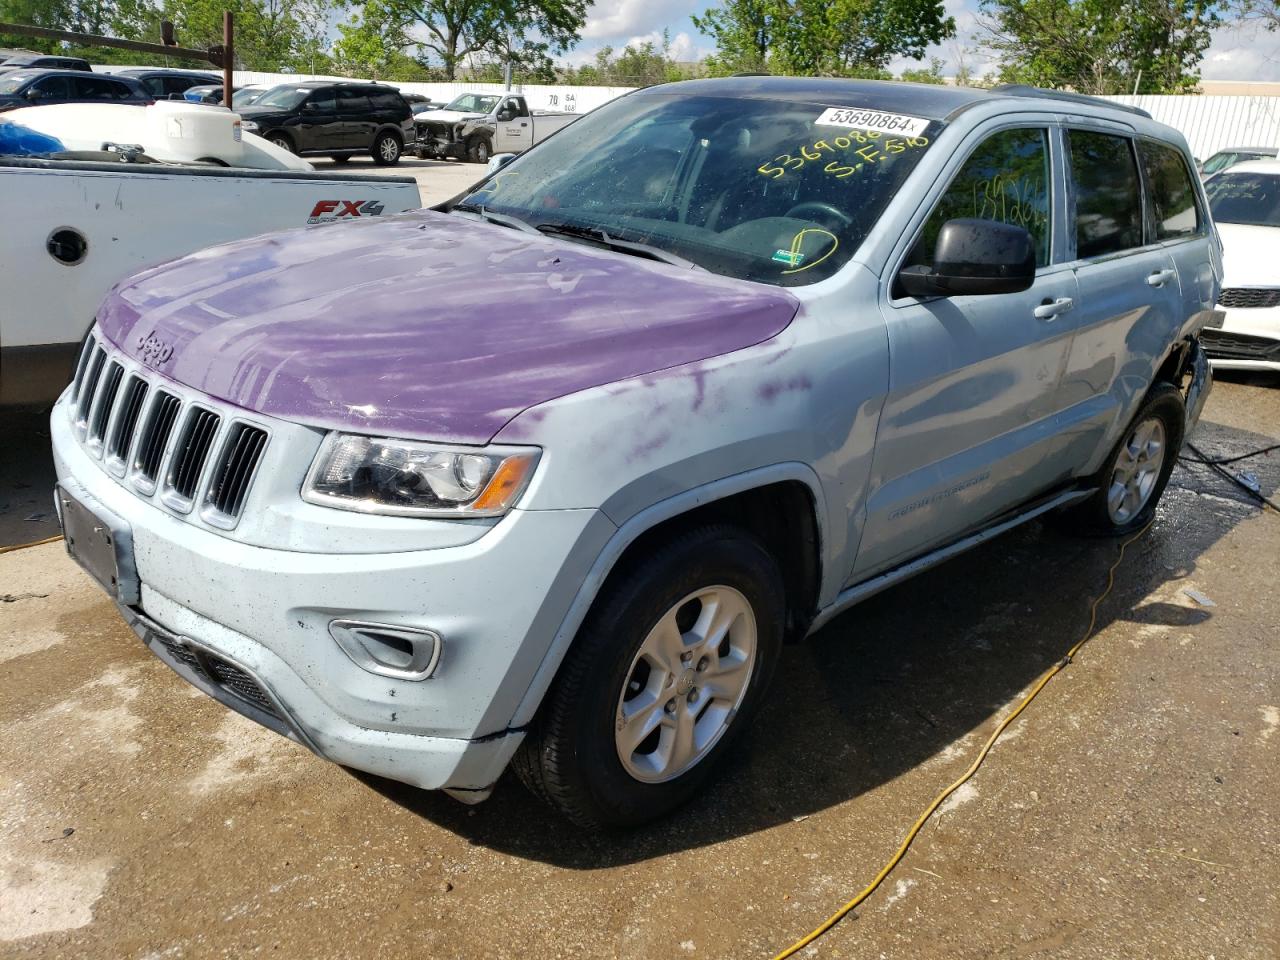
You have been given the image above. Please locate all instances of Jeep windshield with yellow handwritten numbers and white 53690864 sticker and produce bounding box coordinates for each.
[463,93,942,287]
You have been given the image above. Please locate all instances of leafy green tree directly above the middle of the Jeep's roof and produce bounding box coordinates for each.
[694,0,955,77]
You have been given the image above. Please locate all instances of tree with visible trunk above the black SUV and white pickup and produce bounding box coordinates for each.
[340,0,590,81]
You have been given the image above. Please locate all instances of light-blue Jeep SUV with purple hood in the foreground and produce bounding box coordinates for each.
[52,77,1221,827]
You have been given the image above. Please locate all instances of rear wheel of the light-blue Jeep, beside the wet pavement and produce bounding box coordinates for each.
[1061,383,1187,536]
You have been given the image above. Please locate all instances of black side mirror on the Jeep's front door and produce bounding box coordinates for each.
[897,219,1036,297]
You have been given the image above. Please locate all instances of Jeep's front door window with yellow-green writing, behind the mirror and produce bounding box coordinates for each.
[908,129,1052,266]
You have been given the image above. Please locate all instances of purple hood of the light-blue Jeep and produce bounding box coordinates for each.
[99,211,799,444]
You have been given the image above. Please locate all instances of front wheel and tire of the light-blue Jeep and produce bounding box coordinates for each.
[512,526,786,829]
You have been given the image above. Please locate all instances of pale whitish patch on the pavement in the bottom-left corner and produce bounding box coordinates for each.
[0,851,111,942]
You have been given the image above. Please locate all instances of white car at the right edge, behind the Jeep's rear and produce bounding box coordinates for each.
[1201,160,1280,372]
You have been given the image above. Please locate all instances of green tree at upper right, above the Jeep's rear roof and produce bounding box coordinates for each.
[980,0,1220,95]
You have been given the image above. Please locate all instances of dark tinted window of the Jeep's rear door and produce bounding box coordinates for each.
[1068,131,1142,259]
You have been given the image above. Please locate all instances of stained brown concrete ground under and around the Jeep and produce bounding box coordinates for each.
[0,379,1280,960]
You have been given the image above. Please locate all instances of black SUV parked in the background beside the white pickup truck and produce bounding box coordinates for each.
[237,81,413,166]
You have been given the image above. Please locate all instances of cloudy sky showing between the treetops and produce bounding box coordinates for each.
[564,0,1280,81]
